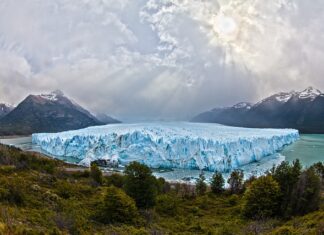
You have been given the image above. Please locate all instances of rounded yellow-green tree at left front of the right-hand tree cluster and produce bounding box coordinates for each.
[243,175,280,219]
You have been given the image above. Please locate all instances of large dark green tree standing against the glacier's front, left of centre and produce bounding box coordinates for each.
[124,162,157,208]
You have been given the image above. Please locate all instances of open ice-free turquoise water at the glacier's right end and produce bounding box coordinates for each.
[281,135,324,167]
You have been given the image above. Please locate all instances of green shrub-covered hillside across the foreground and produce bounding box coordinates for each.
[0,145,324,235]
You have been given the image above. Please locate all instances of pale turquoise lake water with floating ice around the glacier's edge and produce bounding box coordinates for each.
[0,134,324,182]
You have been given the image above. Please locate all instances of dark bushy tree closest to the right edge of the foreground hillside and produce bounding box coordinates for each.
[291,168,321,215]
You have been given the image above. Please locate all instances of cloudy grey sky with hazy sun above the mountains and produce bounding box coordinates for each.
[0,0,324,120]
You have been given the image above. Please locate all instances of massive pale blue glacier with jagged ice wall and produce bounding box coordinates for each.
[32,122,299,172]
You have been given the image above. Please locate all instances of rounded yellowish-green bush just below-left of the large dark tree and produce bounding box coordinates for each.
[98,186,137,224]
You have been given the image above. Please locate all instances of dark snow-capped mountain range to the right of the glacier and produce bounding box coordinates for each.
[191,87,324,133]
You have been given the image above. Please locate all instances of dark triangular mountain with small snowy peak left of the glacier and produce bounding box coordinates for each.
[0,91,111,135]
